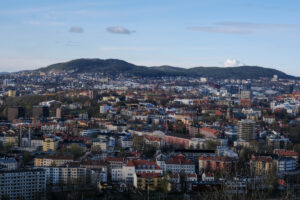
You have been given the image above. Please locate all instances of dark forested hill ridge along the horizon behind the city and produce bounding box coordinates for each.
[35,59,295,79]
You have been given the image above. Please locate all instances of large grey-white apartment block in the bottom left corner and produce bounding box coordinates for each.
[0,169,46,200]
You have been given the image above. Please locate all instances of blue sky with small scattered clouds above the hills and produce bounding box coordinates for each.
[0,0,300,76]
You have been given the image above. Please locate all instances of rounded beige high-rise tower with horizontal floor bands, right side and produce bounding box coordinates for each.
[238,119,255,142]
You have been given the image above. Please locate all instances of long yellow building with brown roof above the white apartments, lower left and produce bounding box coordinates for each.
[34,156,73,167]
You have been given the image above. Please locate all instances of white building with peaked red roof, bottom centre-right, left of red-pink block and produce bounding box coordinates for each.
[166,154,196,174]
